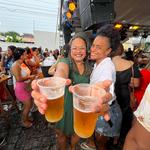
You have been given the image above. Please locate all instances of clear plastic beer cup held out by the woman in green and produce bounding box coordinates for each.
[37,77,66,122]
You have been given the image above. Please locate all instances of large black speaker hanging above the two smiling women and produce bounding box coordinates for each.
[79,0,115,30]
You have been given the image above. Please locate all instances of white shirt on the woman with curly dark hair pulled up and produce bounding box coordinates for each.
[90,57,116,104]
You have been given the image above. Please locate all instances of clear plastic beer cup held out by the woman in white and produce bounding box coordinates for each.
[72,83,106,138]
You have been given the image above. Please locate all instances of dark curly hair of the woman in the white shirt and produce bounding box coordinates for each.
[97,24,121,51]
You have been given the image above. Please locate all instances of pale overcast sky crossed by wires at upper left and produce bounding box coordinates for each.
[0,0,60,33]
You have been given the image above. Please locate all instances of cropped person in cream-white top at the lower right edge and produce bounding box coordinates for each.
[123,84,150,150]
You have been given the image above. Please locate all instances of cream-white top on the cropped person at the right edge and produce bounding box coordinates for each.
[134,83,150,132]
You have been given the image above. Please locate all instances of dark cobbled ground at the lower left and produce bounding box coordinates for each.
[0,105,122,150]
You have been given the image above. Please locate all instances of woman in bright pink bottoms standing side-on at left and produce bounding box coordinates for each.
[11,48,34,128]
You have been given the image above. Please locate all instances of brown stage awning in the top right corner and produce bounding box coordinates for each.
[114,0,150,26]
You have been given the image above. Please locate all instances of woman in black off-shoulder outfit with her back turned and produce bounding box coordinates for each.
[111,44,141,145]
